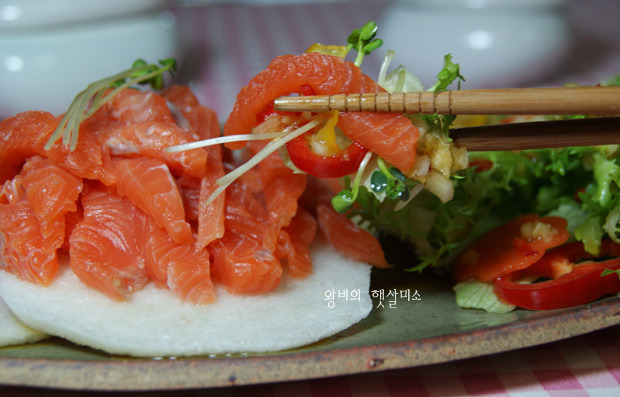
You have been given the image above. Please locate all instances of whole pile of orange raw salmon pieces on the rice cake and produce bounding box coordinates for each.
[0,85,385,304]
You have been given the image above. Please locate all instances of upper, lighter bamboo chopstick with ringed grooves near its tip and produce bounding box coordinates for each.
[274,87,620,116]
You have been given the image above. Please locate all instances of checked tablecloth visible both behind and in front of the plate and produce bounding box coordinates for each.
[0,0,620,397]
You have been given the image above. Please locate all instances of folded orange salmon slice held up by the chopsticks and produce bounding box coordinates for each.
[224,53,419,173]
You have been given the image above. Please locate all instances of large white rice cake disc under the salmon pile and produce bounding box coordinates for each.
[0,243,372,357]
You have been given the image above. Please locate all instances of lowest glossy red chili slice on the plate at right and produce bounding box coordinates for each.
[495,241,620,310]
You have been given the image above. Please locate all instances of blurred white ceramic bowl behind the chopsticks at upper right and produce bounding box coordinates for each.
[379,0,570,89]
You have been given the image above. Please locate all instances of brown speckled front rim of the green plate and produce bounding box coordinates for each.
[0,297,620,391]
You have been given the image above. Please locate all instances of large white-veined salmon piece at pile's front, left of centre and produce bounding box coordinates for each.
[69,184,149,300]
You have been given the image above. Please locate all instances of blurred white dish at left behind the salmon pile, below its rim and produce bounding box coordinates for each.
[0,12,178,117]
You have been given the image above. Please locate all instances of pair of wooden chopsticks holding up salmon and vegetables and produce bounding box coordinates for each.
[274,87,620,151]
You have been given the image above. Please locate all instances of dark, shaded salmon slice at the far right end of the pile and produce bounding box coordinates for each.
[316,203,389,267]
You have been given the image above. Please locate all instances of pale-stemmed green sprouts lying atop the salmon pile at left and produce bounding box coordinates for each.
[45,58,177,151]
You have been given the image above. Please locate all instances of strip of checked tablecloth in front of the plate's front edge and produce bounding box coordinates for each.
[0,326,620,397]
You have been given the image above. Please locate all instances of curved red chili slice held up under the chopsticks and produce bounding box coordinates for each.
[286,136,368,178]
